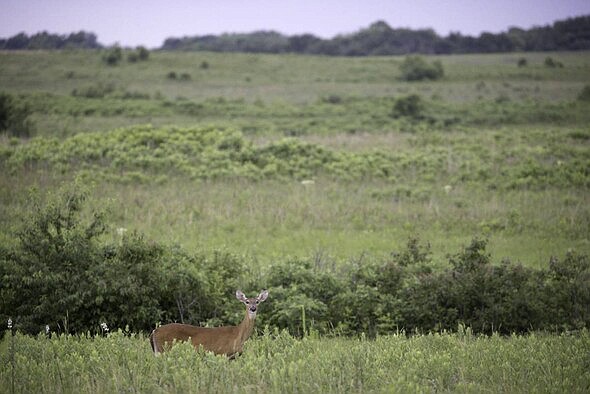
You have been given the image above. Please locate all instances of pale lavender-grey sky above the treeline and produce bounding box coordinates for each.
[0,0,590,48]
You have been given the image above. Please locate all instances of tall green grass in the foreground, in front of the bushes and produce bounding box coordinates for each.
[0,330,590,393]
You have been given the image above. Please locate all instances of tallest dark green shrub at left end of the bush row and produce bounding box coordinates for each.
[0,185,105,333]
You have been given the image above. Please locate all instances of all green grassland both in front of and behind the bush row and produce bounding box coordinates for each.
[0,51,590,393]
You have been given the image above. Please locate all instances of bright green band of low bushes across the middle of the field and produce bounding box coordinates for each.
[0,124,590,189]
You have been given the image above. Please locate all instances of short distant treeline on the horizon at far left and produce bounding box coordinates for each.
[0,31,103,50]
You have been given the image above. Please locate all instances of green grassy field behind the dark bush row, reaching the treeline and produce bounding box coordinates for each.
[0,51,590,274]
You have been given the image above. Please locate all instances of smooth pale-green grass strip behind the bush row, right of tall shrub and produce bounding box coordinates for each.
[95,180,590,267]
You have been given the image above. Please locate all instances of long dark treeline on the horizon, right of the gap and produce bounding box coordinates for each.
[161,16,590,56]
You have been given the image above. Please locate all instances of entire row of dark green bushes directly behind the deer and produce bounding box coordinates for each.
[0,187,590,336]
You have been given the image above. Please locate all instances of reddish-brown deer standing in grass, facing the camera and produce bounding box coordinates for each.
[150,290,268,359]
